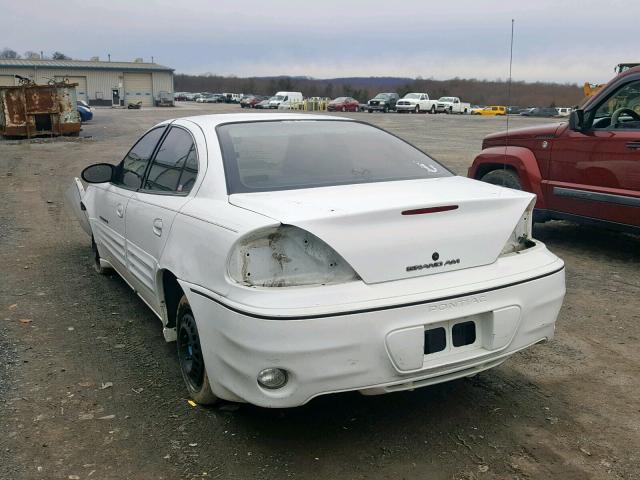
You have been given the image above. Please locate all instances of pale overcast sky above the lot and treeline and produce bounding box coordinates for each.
[0,0,640,84]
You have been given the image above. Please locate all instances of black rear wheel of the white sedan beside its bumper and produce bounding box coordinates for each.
[176,295,218,405]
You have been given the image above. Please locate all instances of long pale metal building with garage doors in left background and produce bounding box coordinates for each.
[0,59,173,106]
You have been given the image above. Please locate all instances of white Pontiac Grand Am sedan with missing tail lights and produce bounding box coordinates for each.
[70,114,565,407]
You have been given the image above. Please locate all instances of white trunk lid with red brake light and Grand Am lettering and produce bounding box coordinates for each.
[229,177,535,283]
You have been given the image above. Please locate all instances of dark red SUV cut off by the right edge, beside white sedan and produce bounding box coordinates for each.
[468,67,640,234]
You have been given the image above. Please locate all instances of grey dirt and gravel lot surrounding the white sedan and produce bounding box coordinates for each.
[0,104,640,480]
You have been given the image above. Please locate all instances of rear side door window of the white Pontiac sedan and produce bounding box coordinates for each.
[144,127,198,193]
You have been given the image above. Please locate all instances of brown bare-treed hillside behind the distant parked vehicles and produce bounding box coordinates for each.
[174,74,583,107]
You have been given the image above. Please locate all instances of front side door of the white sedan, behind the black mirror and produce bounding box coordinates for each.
[91,127,165,273]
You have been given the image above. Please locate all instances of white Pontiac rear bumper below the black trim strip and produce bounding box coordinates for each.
[183,262,565,407]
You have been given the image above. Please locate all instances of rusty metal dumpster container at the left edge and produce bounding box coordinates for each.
[0,76,80,138]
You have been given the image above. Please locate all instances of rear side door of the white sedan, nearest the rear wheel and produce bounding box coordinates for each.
[126,125,204,313]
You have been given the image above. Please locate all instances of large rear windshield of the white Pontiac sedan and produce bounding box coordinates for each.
[216,120,452,194]
